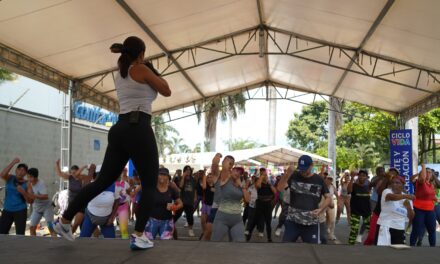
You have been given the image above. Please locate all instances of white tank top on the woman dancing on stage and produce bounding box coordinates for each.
[115,66,157,115]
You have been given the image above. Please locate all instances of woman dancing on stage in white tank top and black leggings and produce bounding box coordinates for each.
[55,37,171,249]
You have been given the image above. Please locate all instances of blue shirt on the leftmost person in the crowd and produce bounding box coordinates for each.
[4,175,27,212]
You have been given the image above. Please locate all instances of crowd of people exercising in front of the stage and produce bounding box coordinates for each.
[0,154,440,246]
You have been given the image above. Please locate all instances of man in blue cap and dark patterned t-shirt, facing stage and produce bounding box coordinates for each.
[277,155,331,244]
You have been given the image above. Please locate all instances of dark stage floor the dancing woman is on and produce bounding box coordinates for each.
[0,235,440,264]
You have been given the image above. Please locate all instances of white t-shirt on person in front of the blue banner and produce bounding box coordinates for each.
[377,189,412,230]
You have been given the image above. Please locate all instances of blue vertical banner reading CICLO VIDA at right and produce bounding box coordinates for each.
[390,129,414,194]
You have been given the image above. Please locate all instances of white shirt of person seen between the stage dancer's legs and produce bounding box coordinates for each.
[87,183,119,217]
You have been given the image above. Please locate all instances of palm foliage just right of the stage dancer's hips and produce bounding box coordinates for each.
[152,116,179,157]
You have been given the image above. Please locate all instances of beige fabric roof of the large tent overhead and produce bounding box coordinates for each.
[0,0,440,116]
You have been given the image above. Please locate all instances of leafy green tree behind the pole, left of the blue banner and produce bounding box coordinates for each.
[287,101,396,170]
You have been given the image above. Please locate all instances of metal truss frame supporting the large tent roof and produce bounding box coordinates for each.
[0,0,440,119]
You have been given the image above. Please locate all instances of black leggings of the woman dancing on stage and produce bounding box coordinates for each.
[63,112,159,232]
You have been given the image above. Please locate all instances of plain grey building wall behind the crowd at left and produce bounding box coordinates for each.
[0,108,107,198]
